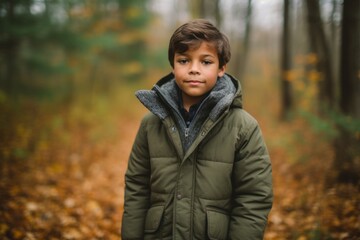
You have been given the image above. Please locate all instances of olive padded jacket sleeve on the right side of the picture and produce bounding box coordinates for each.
[229,119,273,239]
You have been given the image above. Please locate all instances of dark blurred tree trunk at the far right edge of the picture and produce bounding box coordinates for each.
[334,0,360,183]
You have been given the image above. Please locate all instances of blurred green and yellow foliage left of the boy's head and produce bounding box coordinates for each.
[0,0,150,100]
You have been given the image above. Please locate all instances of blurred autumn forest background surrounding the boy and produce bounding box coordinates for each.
[0,0,360,240]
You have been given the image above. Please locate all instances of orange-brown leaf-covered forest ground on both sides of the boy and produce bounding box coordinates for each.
[0,97,360,240]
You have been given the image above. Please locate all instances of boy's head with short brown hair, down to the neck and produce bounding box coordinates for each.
[169,19,230,110]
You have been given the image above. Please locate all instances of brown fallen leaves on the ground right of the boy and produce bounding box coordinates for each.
[265,118,360,240]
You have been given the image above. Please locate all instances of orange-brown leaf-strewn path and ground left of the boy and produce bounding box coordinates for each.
[0,113,139,240]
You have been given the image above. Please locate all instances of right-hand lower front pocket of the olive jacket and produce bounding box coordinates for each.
[206,209,229,240]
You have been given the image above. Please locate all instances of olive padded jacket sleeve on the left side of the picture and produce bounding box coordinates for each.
[121,118,150,240]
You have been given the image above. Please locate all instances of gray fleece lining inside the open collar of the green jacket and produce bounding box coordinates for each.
[136,75,239,151]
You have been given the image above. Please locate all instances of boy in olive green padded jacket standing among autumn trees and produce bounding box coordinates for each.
[121,19,272,240]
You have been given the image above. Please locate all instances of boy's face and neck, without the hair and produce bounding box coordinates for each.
[173,42,225,109]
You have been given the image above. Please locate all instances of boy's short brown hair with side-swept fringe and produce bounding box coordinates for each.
[168,19,231,68]
